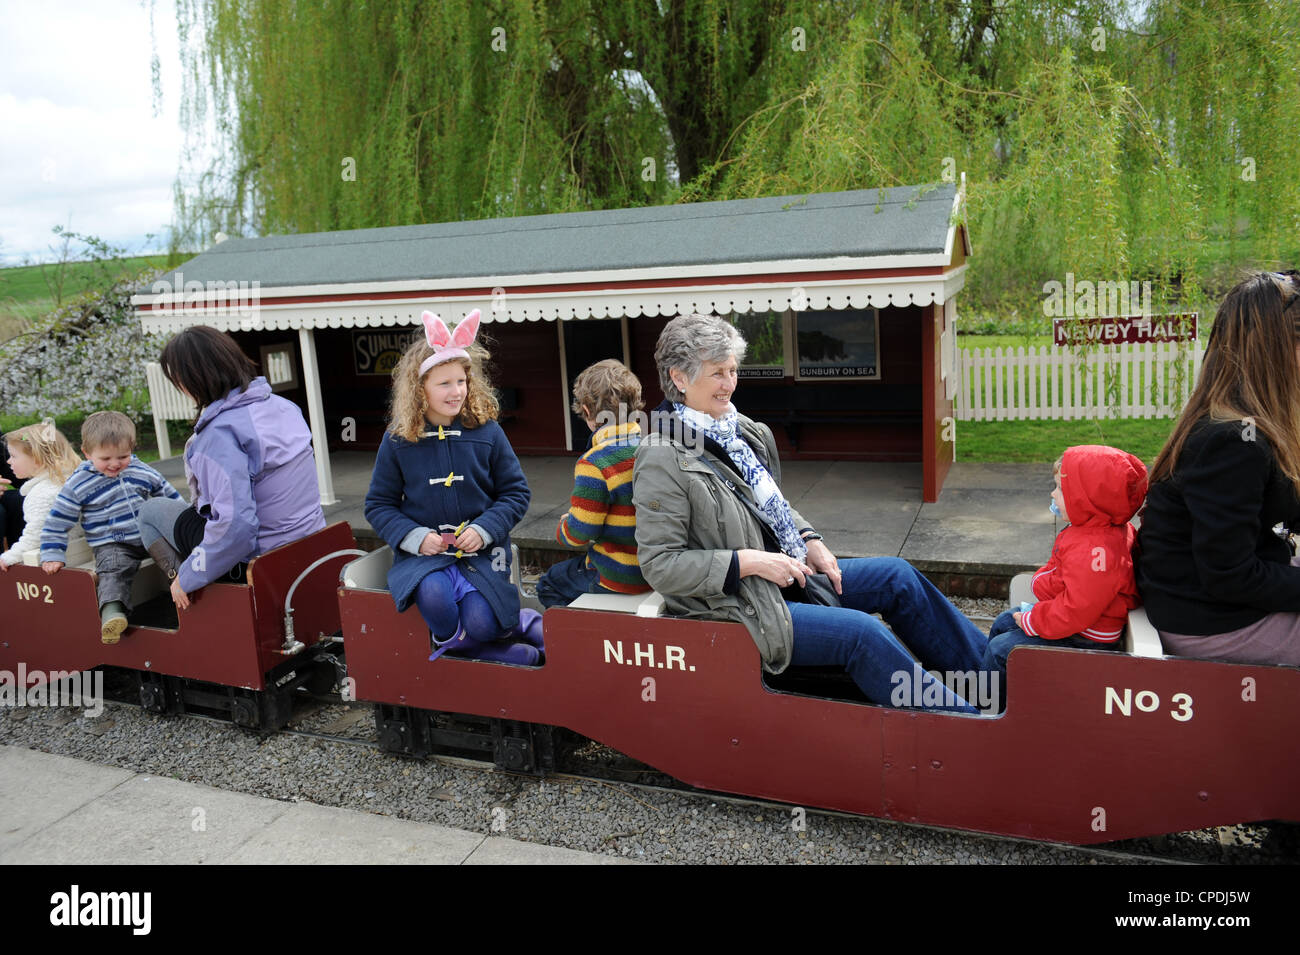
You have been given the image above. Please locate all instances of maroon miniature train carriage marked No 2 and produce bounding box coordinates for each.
[0,524,355,728]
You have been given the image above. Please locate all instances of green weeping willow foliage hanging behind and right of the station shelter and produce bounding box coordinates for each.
[170,0,1300,320]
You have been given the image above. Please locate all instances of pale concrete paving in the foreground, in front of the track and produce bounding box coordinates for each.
[0,746,628,865]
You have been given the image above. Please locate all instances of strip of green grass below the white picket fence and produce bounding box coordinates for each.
[957,418,1174,466]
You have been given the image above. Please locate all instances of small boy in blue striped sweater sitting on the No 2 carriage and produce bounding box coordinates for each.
[40,411,182,643]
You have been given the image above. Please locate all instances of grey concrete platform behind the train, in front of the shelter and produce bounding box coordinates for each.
[156,451,1062,578]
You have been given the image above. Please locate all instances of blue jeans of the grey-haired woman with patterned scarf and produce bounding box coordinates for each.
[788,557,985,713]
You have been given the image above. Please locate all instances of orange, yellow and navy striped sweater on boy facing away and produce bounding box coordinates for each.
[555,422,650,594]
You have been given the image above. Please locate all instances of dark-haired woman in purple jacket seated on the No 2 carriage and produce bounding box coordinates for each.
[139,325,325,609]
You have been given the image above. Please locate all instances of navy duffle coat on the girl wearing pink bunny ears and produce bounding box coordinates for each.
[365,421,530,629]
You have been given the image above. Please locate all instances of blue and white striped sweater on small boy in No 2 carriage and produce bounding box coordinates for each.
[40,455,183,561]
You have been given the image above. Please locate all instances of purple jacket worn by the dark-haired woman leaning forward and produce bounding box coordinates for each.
[177,378,325,592]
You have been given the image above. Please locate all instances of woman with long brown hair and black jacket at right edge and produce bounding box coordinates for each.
[1138,272,1300,665]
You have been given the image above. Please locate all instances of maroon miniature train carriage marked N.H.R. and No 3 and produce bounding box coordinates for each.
[339,551,1300,845]
